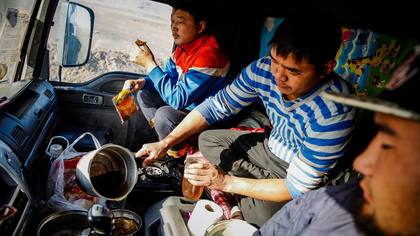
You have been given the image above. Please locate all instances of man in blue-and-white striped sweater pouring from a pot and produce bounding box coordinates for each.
[137,12,355,225]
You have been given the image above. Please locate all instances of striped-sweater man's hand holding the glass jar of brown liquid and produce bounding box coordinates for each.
[184,159,228,191]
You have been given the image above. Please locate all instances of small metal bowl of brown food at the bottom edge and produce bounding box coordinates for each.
[112,209,142,236]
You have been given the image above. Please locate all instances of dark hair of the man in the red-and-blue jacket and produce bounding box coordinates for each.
[171,0,210,33]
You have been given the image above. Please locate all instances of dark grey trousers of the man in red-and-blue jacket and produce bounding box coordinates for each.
[137,90,188,140]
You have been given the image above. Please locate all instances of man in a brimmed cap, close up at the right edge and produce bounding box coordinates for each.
[254,47,420,235]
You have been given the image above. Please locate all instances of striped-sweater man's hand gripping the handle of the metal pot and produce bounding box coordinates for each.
[136,141,168,166]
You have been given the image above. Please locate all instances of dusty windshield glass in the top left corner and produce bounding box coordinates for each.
[0,0,35,88]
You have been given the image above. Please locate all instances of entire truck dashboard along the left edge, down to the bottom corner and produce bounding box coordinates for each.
[0,80,57,235]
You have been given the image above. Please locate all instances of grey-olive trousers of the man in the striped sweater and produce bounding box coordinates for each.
[198,129,289,226]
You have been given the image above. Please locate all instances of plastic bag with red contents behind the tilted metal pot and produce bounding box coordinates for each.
[47,132,101,211]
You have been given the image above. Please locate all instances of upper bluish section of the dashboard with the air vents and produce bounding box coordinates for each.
[0,80,57,168]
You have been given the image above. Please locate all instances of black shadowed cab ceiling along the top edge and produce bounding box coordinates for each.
[154,0,420,41]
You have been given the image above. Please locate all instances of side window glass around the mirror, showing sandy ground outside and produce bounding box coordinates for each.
[48,0,173,83]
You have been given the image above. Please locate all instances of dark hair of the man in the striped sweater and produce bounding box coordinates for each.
[270,9,341,72]
